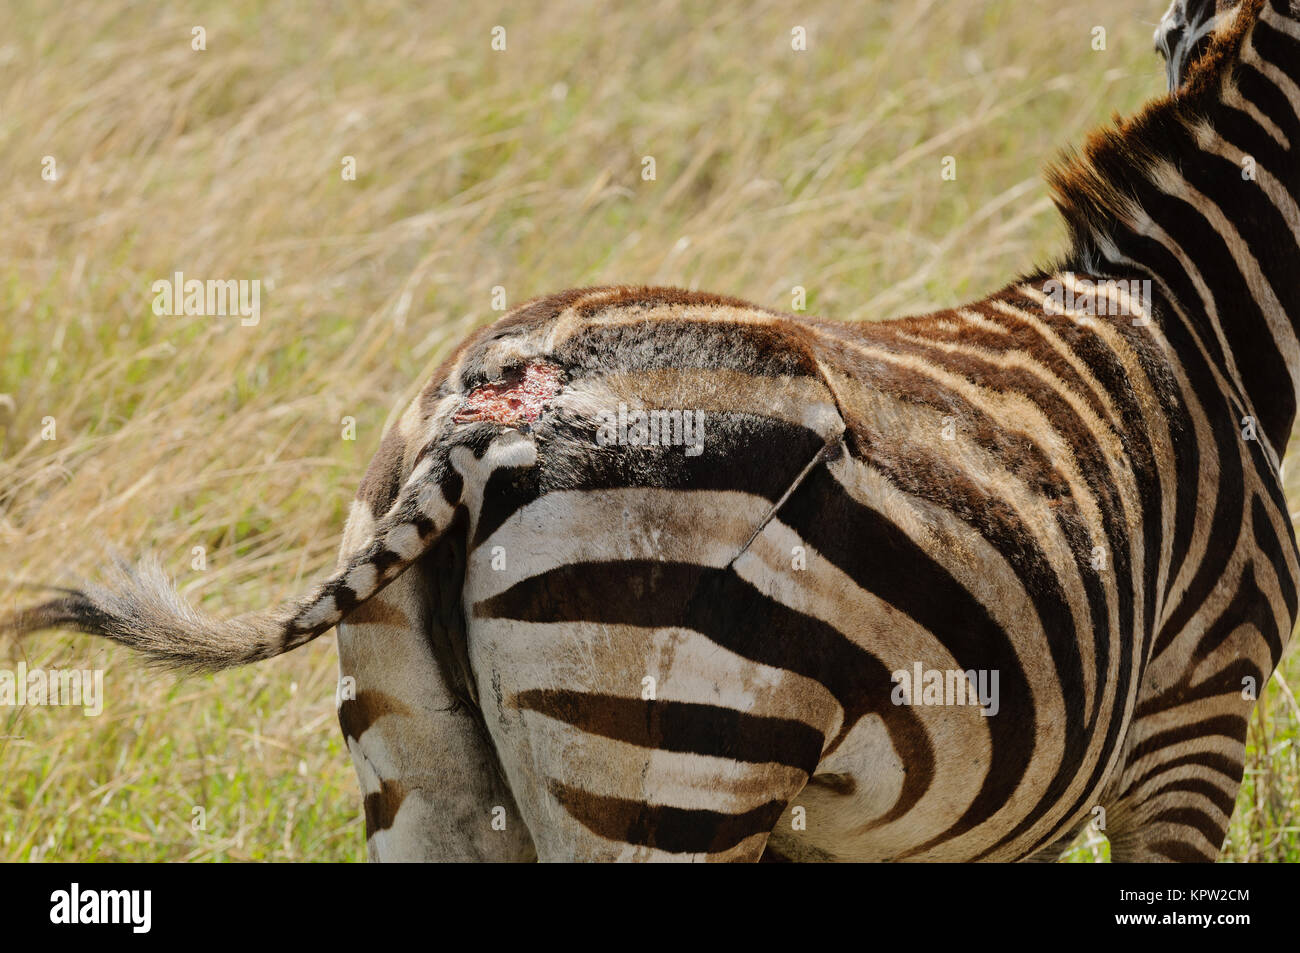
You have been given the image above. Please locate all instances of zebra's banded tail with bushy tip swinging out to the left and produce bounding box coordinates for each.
[0,447,463,672]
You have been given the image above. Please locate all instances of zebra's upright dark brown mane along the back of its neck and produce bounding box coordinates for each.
[1047,0,1268,263]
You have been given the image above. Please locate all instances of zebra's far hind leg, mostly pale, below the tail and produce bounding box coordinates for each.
[338,502,536,861]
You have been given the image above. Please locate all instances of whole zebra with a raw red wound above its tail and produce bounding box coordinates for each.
[4,0,1300,862]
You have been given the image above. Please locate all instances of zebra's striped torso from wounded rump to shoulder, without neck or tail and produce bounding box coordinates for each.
[325,265,1295,859]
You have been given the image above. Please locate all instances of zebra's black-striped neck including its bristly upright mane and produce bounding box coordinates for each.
[1049,0,1300,458]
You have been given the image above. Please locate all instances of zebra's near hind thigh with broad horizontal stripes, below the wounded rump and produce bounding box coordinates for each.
[463,400,841,861]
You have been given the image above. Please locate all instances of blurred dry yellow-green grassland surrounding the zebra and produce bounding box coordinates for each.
[0,0,1300,861]
